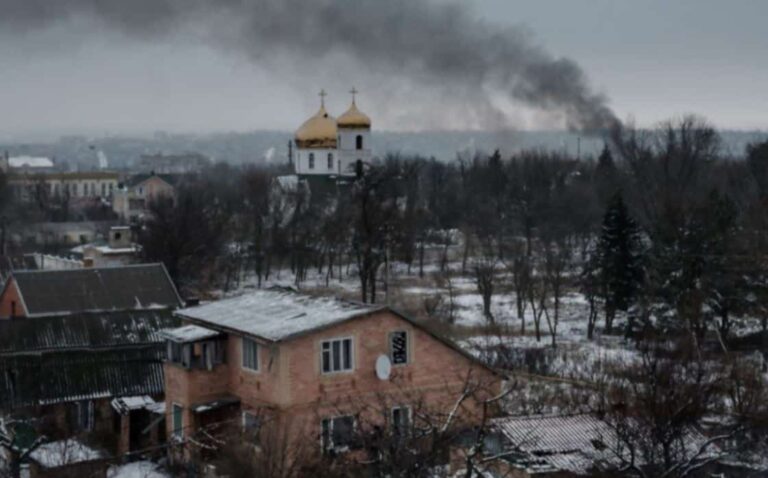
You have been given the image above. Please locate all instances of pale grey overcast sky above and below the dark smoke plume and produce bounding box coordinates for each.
[0,0,768,140]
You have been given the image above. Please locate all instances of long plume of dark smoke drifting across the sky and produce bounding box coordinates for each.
[0,0,619,131]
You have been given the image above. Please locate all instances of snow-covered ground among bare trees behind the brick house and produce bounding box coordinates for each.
[214,250,760,390]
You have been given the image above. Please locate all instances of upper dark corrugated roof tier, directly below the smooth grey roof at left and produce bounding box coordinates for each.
[0,310,180,355]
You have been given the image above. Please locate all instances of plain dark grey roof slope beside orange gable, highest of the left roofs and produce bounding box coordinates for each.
[13,263,183,317]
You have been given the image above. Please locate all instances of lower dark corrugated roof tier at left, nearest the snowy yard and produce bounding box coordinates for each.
[0,345,165,409]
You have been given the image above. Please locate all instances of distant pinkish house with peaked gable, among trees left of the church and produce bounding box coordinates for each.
[112,173,179,221]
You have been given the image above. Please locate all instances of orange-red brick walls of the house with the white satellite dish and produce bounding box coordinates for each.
[165,312,501,454]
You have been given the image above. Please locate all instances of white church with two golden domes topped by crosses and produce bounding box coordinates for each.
[291,88,371,177]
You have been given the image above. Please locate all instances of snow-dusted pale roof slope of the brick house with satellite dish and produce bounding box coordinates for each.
[177,289,384,341]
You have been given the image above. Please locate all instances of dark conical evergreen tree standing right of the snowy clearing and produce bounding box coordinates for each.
[596,193,643,333]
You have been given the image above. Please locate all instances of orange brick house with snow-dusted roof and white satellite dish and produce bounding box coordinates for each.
[164,289,502,466]
